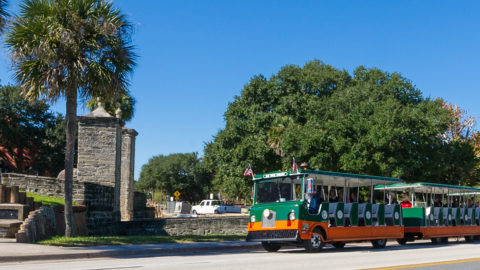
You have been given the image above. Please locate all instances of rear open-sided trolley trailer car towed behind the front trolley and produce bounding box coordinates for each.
[375,182,480,244]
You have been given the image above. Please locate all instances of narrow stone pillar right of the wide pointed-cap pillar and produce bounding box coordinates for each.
[120,128,138,221]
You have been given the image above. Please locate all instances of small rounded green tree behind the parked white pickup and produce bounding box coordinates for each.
[137,153,211,202]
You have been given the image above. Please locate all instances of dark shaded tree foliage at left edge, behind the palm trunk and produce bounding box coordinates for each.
[0,86,65,176]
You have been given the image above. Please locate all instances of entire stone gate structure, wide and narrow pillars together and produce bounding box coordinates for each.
[77,102,138,234]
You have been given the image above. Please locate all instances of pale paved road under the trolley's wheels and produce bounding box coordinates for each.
[0,239,480,270]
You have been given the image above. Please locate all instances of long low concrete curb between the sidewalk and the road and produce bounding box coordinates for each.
[0,243,261,265]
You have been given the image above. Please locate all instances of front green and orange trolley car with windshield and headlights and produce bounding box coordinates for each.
[247,170,404,252]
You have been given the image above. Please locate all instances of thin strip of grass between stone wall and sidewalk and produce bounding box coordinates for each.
[37,234,247,247]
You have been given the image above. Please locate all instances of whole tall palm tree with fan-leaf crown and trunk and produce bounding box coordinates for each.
[6,0,135,237]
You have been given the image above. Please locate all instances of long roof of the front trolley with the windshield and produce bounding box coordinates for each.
[253,170,402,187]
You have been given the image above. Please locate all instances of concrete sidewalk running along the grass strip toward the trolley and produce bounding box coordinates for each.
[0,239,261,264]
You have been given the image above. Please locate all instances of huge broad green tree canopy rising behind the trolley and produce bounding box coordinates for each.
[204,61,476,200]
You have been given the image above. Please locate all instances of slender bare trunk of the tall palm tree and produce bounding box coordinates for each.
[65,88,77,237]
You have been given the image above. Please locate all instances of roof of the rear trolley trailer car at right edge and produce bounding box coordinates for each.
[375,182,480,195]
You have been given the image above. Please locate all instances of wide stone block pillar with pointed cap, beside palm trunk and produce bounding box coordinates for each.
[77,104,122,234]
